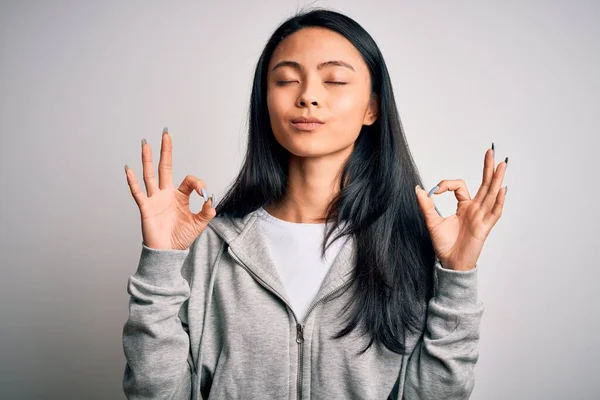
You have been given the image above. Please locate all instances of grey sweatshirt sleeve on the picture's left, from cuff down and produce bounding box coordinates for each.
[123,243,194,400]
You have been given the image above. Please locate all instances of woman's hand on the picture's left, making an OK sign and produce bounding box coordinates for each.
[125,128,216,250]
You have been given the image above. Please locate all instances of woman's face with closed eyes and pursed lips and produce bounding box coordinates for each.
[267,27,377,157]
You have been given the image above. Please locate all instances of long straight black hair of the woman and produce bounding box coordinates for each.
[217,8,436,354]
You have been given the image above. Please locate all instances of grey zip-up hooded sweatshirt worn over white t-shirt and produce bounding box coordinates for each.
[123,211,484,400]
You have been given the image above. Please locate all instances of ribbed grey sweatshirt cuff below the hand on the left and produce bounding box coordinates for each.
[134,243,190,287]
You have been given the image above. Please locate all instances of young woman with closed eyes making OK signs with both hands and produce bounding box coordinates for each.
[123,9,508,400]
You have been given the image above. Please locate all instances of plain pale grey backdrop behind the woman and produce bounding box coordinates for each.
[0,0,600,400]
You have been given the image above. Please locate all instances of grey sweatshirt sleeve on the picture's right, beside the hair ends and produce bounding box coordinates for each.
[402,260,484,400]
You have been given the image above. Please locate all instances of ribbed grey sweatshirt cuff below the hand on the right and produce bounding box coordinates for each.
[435,261,479,309]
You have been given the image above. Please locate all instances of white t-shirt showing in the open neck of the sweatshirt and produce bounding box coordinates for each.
[257,207,344,320]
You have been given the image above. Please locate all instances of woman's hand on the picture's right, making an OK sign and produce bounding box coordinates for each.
[415,149,508,271]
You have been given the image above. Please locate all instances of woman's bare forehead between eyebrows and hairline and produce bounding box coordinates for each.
[269,27,367,72]
